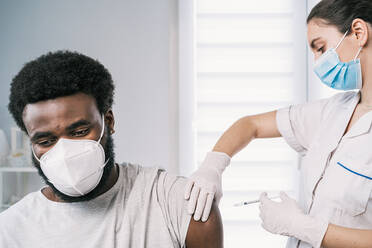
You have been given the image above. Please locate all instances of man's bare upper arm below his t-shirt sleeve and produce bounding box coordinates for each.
[186,204,223,248]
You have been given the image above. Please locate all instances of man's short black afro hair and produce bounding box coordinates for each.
[8,51,114,132]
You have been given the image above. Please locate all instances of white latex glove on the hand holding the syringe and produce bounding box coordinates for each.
[260,192,328,248]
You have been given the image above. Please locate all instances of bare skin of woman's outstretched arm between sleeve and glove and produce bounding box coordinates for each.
[213,111,281,157]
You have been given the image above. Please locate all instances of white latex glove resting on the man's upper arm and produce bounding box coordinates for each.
[185,152,231,222]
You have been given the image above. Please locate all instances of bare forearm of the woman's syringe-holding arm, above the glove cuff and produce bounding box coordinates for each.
[322,224,372,248]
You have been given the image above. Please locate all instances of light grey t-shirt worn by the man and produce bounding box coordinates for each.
[0,164,191,248]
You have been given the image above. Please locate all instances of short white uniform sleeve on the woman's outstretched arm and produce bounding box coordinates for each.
[276,96,330,155]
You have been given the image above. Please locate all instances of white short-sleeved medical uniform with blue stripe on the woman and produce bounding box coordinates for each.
[276,92,372,248]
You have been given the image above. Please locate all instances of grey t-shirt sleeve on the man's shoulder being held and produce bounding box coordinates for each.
[157,171,191,247]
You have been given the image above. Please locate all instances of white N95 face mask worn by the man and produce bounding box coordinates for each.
[32,115,108,197]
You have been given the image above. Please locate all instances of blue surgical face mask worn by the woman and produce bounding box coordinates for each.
[314,31,362,90]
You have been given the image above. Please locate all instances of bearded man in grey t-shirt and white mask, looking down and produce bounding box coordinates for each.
[0,51,223,248]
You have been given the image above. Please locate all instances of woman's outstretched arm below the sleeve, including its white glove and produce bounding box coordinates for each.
[185,111,281,221]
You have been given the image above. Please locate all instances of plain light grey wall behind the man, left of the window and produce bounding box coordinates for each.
[0,0,178,172]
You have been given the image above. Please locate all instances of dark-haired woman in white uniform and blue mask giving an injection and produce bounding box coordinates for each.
[185,0,372,248]
